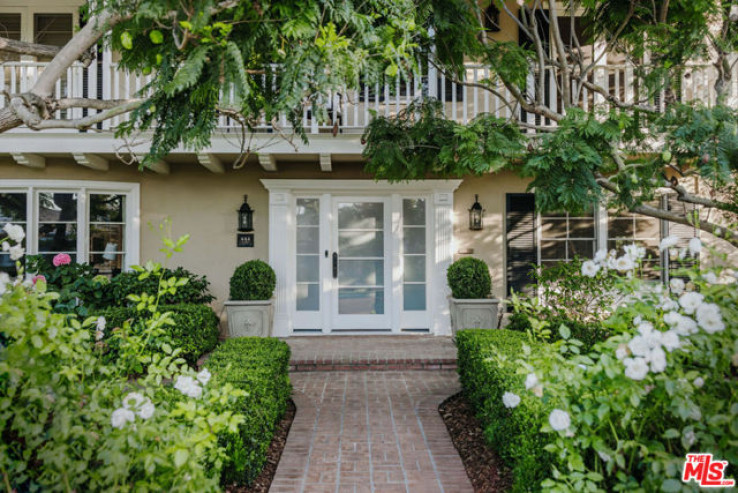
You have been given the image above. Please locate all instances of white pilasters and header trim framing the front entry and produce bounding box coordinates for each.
[261,179,461,337]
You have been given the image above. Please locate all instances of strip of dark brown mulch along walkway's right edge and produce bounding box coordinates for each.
[438,393,511,493]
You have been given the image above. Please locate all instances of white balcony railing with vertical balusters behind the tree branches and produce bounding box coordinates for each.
[0,57,738,133]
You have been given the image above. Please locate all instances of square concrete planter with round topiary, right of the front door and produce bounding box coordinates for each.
[446,257,500,334]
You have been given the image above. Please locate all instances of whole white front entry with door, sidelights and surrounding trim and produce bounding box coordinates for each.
[261,179,461,337]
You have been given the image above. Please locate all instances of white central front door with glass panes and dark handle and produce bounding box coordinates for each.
[328,197,392,331]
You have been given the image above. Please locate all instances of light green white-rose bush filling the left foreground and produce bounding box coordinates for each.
[0,232,245,492]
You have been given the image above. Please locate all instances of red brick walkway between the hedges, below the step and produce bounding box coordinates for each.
[270,370,473,493]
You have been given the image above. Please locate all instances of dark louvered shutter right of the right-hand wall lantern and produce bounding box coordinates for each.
[505,193,538,296]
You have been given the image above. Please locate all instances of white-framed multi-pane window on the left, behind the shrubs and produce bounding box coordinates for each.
[0,180,139,276]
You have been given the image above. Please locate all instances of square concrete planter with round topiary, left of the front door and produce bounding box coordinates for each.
[225,260,277,337]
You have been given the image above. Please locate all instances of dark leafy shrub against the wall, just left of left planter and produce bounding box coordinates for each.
[109,267,215,306]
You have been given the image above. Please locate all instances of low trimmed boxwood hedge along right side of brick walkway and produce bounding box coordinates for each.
[456,329,555,492]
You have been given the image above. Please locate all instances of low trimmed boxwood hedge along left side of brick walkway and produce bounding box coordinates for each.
[205,337,292,486]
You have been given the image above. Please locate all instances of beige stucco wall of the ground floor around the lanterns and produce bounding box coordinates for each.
[0,158,525,310]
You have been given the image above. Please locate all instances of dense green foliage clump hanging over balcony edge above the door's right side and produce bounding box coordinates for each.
[362,99,525,181]
